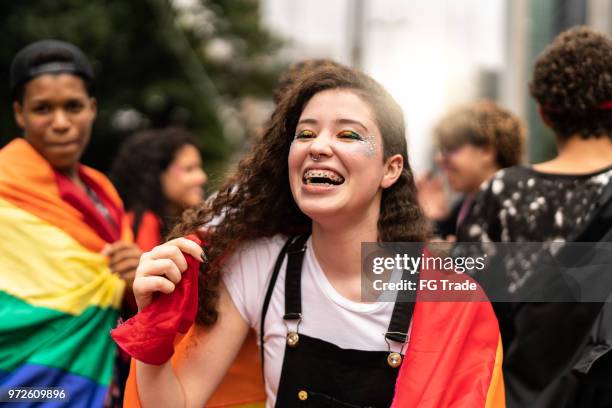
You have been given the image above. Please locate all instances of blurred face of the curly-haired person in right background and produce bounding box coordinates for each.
[436,143,496,193]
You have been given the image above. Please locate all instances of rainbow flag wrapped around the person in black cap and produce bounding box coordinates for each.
[0,138,131,407]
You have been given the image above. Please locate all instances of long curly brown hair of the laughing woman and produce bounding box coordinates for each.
[172,66,428,325]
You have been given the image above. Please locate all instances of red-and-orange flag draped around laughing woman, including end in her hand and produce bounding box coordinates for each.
[113,244,505,408]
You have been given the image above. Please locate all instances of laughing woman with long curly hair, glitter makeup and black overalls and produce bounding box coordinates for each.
[115,66,503,407]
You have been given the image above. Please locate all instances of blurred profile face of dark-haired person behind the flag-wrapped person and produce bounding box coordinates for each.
[161,145,208,210]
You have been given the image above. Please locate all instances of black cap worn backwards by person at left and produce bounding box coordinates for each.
[9,40,94,100]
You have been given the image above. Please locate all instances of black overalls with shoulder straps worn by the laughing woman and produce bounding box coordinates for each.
[260,236,414,408]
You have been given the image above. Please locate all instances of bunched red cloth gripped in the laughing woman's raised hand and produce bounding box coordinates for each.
[111,237,200,365]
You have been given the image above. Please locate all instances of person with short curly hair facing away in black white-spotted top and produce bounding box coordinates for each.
[458,27,612,407]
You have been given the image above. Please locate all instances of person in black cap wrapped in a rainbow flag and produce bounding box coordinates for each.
[0,40,140,406]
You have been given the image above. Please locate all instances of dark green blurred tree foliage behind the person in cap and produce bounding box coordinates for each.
[0,0,281,177]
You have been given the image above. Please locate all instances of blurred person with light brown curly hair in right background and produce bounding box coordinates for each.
[417,100,525,240]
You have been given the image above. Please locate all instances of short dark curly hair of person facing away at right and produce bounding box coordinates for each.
[529,26,612,139]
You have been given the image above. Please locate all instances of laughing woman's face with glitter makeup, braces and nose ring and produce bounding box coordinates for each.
[289,89,403,222]
